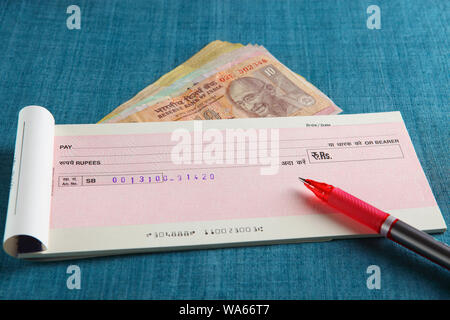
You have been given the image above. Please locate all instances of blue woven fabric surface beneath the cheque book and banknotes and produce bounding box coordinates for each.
[0,0,450,299]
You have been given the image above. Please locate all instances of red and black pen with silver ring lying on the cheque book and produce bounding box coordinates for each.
[299,178,450,270]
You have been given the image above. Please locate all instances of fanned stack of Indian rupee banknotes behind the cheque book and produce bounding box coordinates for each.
[100,40,342,123]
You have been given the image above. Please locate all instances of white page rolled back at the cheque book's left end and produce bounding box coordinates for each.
[3,106,55,257]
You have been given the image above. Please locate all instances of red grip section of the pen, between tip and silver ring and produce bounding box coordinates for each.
[328,187,389,233]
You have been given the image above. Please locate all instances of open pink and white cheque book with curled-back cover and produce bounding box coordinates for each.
[4,106,446,260]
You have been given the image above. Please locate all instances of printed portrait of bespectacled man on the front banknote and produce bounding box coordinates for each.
[226,77,315,118]
